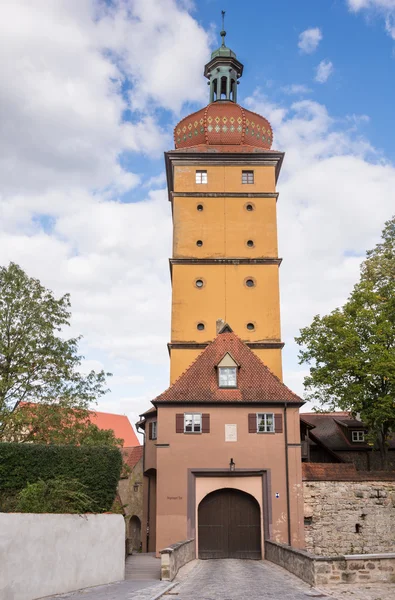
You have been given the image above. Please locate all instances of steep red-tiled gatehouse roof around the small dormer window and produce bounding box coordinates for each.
[153,332,303,404]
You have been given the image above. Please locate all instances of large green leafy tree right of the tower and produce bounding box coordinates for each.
[296,217,395,468]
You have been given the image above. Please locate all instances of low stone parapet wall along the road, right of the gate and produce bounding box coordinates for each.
[265,541,395,586]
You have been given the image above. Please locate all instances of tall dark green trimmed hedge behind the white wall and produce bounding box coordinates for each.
[0,443,122,512]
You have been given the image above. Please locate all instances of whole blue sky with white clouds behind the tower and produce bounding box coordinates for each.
[0,0,395,432]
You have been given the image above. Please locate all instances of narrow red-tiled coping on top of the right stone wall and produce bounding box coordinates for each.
[302,463,395,481]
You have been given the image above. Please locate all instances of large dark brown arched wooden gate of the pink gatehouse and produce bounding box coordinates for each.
[198,488,262,560]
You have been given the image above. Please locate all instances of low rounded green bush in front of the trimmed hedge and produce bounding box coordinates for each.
[16,477,96,514]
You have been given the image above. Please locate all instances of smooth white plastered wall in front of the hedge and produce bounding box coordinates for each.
[0,513,125,600]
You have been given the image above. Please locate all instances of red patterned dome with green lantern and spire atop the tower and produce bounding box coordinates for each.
[174,11,273,152]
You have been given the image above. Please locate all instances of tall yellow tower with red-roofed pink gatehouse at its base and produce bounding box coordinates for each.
[137,25,304,559]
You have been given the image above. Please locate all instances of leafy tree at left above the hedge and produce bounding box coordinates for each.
[0,263,119,445]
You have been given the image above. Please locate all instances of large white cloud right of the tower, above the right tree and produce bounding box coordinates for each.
[246,94,395,393]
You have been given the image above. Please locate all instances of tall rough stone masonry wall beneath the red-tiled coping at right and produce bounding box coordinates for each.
[303,481,395,556]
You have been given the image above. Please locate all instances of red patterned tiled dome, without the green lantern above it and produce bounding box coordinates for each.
[174,101,273,150]
